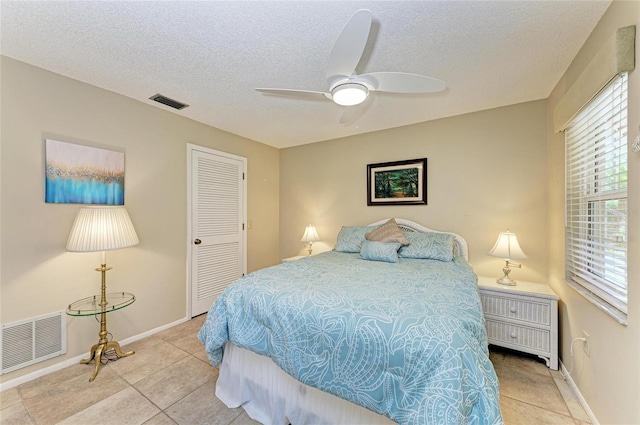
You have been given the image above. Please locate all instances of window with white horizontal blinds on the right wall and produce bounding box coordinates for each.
[565,73,627,324]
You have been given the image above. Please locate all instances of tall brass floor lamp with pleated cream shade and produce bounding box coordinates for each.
[67,206,139,381]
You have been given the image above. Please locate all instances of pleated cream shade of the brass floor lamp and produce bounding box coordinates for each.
[67,206,140,252]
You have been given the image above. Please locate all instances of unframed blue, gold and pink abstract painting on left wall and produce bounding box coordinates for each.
[45,139,124,205]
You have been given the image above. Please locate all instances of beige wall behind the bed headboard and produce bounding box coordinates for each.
[280,101,547,281]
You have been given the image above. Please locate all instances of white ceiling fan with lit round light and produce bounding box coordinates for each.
[256,9,446,124]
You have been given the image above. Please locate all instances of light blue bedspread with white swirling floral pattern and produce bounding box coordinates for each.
[198,251,502,425]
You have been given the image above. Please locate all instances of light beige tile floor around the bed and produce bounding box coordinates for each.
[0,315,590,425]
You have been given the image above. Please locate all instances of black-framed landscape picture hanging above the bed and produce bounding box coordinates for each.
[367,158,427,205]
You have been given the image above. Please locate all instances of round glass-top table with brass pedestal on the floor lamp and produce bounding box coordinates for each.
[66,285,136,382]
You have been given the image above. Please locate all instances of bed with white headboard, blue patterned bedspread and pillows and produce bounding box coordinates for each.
[198,219,503,425]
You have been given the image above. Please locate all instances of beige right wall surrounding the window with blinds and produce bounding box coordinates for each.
[547,1,640,424]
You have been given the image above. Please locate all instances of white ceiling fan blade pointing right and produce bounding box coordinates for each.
[356,72,447,93]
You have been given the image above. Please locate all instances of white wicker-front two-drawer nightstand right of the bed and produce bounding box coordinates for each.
[478,276,558,370]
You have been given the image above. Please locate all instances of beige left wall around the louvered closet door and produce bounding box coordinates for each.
[0,57,279,382]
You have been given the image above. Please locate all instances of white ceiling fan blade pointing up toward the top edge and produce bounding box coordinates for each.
[326,9,372,84]
